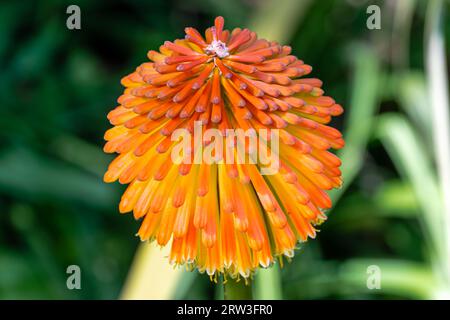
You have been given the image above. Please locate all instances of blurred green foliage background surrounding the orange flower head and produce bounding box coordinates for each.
[0,0,450,299]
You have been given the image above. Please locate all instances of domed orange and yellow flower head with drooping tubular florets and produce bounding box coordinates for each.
[104,17,344,278]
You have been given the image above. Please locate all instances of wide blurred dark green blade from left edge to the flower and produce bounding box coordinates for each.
[0,148,117,209]
